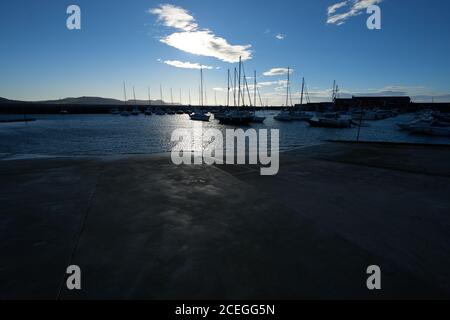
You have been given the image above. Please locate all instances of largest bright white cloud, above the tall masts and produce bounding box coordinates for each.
[149,4,252,63]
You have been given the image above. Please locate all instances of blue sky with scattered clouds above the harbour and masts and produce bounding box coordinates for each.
[0,0,450,104]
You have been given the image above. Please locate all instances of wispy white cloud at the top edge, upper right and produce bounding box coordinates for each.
[327,0,383,26]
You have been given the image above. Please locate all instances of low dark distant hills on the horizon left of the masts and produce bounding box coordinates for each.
[0,97,166,106]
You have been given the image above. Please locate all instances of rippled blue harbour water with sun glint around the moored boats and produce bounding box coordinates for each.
[0,111,450,159]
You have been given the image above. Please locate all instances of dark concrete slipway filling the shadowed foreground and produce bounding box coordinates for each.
[0,143,450,299]
